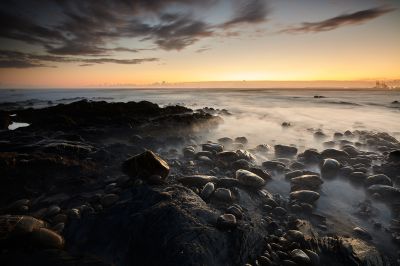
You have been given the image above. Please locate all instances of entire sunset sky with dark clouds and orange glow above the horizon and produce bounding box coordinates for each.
[0,0,400,88]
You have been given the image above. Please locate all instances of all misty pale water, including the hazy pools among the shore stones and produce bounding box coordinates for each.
[0,89,400,252]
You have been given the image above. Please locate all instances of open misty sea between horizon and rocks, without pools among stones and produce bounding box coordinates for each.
[0,89,400,149]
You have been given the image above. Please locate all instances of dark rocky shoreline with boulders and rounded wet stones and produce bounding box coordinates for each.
[0,101,400,265]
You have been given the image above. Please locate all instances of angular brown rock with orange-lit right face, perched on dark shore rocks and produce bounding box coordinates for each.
[122,150,169,179]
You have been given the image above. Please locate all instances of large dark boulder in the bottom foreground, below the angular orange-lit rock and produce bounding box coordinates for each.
[64,185,266,266]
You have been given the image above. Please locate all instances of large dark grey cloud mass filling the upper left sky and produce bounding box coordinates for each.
[0,0,268,68]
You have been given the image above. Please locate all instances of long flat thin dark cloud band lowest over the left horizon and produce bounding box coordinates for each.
[0,50,159,68]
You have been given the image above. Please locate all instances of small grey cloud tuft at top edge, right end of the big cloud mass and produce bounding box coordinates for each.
[223,0,269,27]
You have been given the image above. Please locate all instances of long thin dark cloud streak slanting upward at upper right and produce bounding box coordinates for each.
[281,7,395,33]
